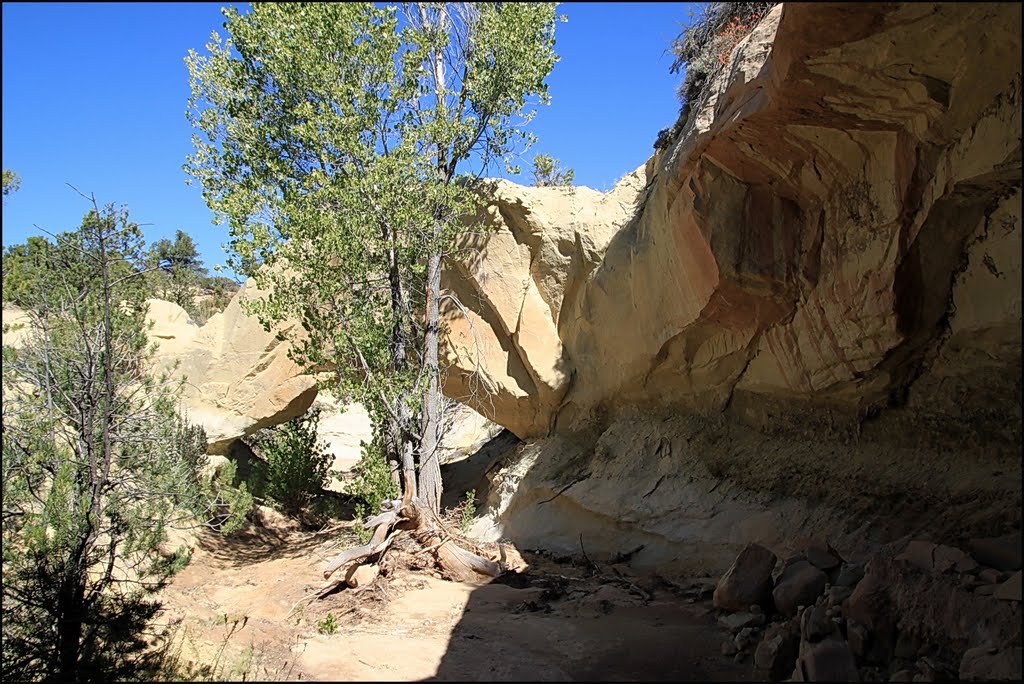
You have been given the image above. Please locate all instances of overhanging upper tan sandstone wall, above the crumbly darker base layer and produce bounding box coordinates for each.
[444,3,1021,438]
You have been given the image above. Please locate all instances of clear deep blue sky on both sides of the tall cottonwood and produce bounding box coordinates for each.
[3,2,698,274]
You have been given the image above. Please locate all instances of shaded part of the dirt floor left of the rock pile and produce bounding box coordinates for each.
[424,552,757,682]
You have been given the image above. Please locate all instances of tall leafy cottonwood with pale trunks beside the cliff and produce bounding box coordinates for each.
[186,3,557,581]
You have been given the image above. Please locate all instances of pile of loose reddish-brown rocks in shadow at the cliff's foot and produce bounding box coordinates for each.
[714,536,1022,682]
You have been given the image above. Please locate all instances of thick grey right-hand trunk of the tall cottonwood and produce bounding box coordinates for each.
[419,252,441,513]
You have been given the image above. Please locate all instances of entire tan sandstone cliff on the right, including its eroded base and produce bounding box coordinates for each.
[445,3,1021,569]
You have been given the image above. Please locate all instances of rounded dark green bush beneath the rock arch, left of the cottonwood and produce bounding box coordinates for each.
[250,407,332,515]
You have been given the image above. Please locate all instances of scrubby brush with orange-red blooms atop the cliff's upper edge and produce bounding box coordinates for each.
[655,2,778,122]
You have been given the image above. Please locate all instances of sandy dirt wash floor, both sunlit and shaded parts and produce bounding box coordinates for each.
[155,516,752,681]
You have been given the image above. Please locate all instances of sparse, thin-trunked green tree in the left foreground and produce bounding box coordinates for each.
[2,196,247,681]
